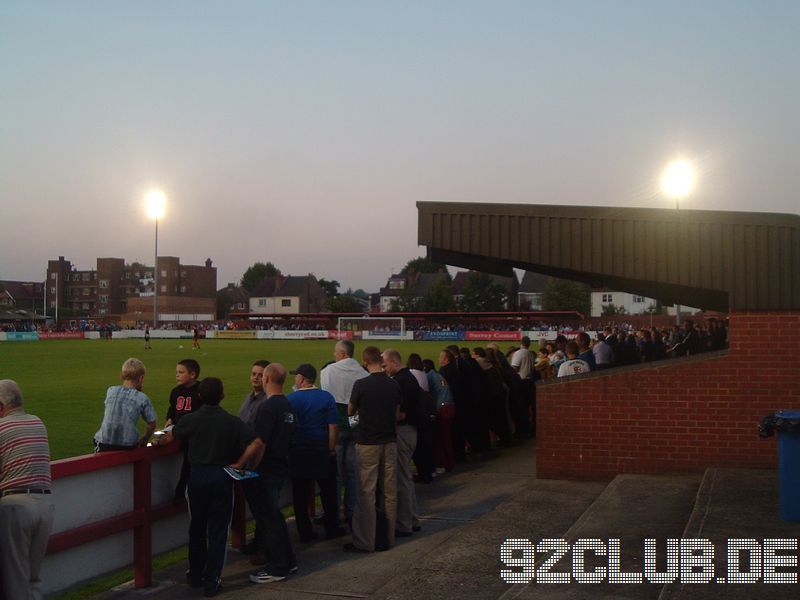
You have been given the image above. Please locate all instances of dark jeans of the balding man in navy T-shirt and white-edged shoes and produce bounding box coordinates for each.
[250,473,297,575]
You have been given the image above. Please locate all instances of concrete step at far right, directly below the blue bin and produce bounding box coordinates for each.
[659,469,800,600]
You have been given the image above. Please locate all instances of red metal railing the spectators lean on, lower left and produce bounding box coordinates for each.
[47,443,247,587]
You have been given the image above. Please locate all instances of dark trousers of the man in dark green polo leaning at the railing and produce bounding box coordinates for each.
[188,465,233,583]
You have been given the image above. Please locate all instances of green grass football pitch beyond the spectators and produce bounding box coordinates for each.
[0,339,462,460]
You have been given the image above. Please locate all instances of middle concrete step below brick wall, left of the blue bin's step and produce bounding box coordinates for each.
[502,475,701,600]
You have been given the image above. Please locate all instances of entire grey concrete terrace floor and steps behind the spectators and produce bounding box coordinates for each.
[97,441,800,600]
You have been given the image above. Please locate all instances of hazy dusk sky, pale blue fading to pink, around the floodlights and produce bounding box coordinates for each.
[0,0,800,291]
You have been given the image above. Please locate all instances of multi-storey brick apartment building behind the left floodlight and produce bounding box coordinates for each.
[47,256,217,321]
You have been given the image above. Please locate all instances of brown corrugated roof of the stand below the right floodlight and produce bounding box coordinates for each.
[417,202,800,311]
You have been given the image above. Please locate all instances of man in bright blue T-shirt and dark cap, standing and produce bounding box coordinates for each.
[288,363,346,542]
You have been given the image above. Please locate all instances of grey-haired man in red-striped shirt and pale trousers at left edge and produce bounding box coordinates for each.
[0,379,55,600]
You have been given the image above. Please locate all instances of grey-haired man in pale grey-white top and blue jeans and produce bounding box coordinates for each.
[320,340,369,526]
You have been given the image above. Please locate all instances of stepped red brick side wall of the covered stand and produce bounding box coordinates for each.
[536,311,800,479]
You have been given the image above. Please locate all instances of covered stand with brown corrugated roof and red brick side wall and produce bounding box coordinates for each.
[417,202,800,479]
